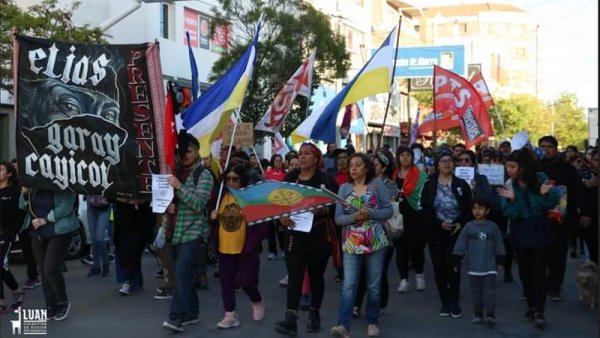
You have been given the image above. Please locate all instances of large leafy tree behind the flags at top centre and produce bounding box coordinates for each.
[210,0,350,139]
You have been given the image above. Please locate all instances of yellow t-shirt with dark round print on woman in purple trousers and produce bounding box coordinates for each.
[218,193,246,254]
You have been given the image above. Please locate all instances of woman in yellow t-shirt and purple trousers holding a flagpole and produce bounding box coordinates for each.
[210,165,267,329]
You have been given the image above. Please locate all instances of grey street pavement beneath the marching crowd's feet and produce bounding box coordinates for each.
[0,246,598,338]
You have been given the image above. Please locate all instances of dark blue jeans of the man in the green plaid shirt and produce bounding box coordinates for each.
[169,239,200,323]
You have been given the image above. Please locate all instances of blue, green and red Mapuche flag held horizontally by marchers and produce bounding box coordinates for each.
[229,180,338,225]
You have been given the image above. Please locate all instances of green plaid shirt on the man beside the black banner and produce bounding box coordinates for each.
[171,163,213,245]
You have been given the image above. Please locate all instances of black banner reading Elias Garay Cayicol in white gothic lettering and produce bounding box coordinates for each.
[13,36,166,198]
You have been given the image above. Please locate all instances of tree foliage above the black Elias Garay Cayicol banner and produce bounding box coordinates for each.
[0,0,106,93]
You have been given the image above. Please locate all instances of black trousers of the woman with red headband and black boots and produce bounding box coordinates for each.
[285,247,329,310]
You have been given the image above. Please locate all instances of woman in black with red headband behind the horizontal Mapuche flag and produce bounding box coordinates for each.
[275,142,338,336]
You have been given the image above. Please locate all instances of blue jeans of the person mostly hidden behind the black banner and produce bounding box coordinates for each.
[87,204,110,270]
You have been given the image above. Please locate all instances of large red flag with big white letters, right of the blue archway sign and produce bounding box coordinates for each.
[433,66,494,148]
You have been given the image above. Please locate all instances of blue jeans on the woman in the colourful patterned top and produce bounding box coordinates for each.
[338,250,386,330]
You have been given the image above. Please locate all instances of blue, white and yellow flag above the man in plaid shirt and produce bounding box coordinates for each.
[183,23,261,157]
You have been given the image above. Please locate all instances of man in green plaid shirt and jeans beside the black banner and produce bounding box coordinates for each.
[162,133,213,332]
